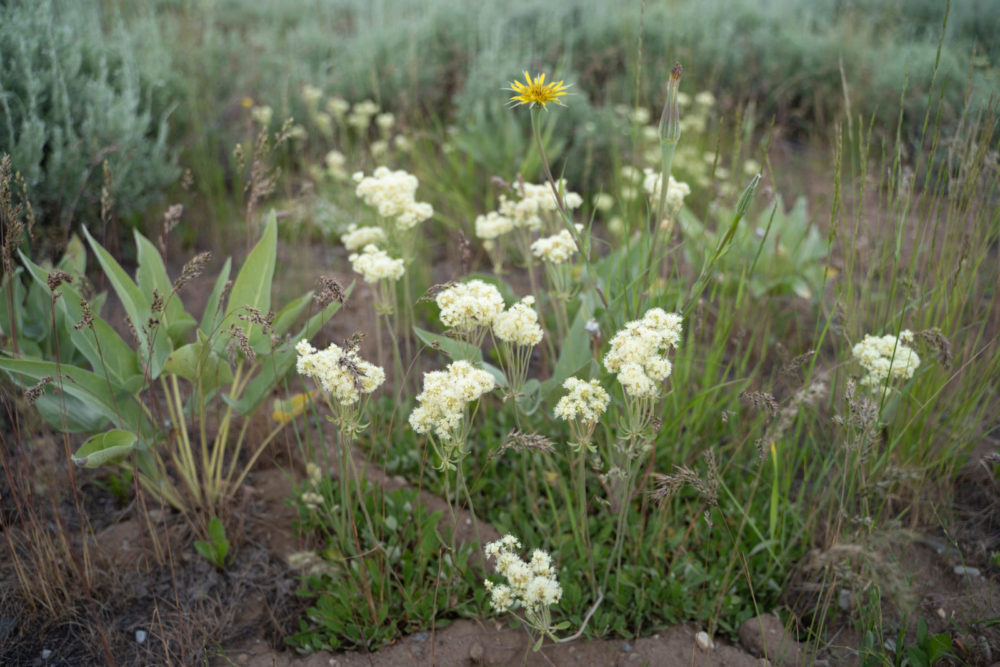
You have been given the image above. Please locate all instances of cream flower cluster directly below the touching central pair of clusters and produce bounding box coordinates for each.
[410,361,496,442]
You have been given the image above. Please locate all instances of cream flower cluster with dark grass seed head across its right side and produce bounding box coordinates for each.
[295,340,385,406]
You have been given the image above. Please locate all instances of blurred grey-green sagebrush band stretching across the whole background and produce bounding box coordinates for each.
[0,0,1000,245]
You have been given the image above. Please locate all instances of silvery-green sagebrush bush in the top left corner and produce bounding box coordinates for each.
[0,0,179,227]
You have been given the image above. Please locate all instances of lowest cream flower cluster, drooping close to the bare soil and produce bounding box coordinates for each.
[483,535,562,613]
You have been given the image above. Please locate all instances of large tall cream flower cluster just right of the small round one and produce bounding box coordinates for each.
[604,308,682,398]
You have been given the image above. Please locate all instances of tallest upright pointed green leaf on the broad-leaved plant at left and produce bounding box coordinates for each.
[222,210,278,350]
